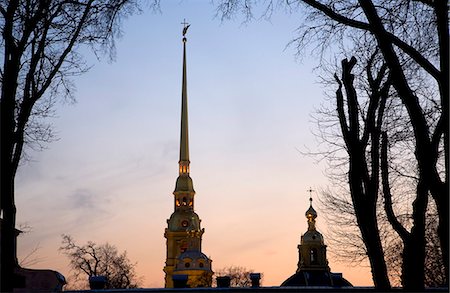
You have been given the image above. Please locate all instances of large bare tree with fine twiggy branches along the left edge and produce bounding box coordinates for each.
[0,0,158,291]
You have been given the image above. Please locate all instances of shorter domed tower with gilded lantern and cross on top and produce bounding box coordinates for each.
[281,189,352,287]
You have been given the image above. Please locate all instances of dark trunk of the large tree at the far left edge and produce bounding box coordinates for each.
[0,0,20,292]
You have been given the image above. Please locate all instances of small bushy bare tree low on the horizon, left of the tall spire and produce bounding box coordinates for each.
[59,235,139,289]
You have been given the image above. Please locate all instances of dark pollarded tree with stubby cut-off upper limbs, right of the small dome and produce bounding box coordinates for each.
[335,57,391,289]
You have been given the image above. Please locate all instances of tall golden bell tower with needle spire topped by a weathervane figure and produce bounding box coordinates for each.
[164,24,213,288]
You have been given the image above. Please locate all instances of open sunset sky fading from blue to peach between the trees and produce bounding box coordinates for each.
[16,0,372,287]
